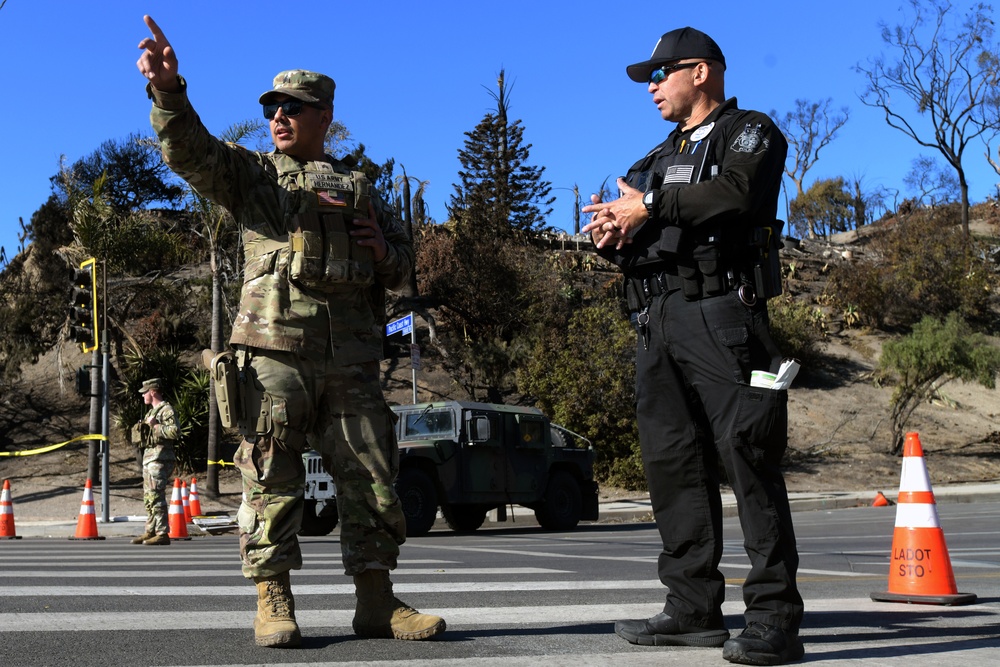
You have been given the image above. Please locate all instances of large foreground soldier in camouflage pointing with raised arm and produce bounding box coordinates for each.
[137,16,445,646]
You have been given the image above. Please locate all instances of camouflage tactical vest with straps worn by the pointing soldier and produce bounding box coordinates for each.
[243,158,375,292]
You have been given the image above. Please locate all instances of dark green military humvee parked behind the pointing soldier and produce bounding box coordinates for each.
[302,401,598,537]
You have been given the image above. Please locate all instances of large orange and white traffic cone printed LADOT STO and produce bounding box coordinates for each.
[871,433,976,605]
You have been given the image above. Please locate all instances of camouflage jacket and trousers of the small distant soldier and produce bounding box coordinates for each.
[133,401,179,535]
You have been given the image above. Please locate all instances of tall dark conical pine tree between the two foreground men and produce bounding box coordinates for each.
[448,70,555,238]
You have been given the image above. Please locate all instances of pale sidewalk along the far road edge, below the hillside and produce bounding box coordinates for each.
[13,482,1000,538]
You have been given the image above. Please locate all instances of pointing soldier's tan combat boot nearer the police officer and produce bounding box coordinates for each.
[353,570,445,639]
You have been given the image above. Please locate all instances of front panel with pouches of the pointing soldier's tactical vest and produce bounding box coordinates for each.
[288,171,375,290]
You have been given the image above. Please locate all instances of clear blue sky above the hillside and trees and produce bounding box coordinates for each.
[0,0,1000,255]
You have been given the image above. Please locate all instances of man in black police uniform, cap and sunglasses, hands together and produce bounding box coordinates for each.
[583,28,803,664]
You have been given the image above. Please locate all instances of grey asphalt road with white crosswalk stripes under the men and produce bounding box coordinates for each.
[0,502,1000,667]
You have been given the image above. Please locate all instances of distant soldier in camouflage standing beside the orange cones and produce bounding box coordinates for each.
[132,378,178,545]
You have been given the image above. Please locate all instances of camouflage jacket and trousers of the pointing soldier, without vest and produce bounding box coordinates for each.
[148,78,413,578]
